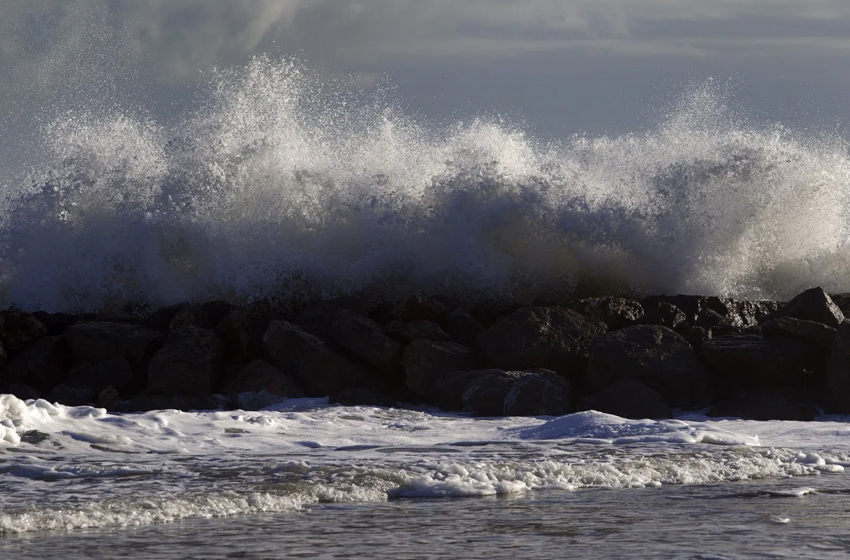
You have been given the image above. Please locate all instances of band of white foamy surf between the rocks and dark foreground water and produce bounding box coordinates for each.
[0,395,850,534]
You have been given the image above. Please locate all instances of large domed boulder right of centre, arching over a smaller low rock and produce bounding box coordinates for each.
[586,325,711,408]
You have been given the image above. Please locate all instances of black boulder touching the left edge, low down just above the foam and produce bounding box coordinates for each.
[0,336,70,393]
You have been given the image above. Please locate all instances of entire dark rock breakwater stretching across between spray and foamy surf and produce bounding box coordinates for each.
[0,288,850,420]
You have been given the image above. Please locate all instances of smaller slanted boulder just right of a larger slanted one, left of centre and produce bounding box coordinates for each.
[328,309,402,376]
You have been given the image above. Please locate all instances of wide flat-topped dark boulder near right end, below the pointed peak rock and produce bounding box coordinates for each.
[701,334,826,394]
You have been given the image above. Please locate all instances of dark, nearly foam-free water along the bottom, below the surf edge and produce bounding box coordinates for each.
[6,476,850,559]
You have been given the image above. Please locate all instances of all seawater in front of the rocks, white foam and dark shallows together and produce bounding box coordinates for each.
[0,395,850,559]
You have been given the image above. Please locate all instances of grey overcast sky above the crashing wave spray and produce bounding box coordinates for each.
[0,0,850,166]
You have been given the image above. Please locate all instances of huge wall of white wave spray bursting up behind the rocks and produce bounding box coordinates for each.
[0,57,850,311]
